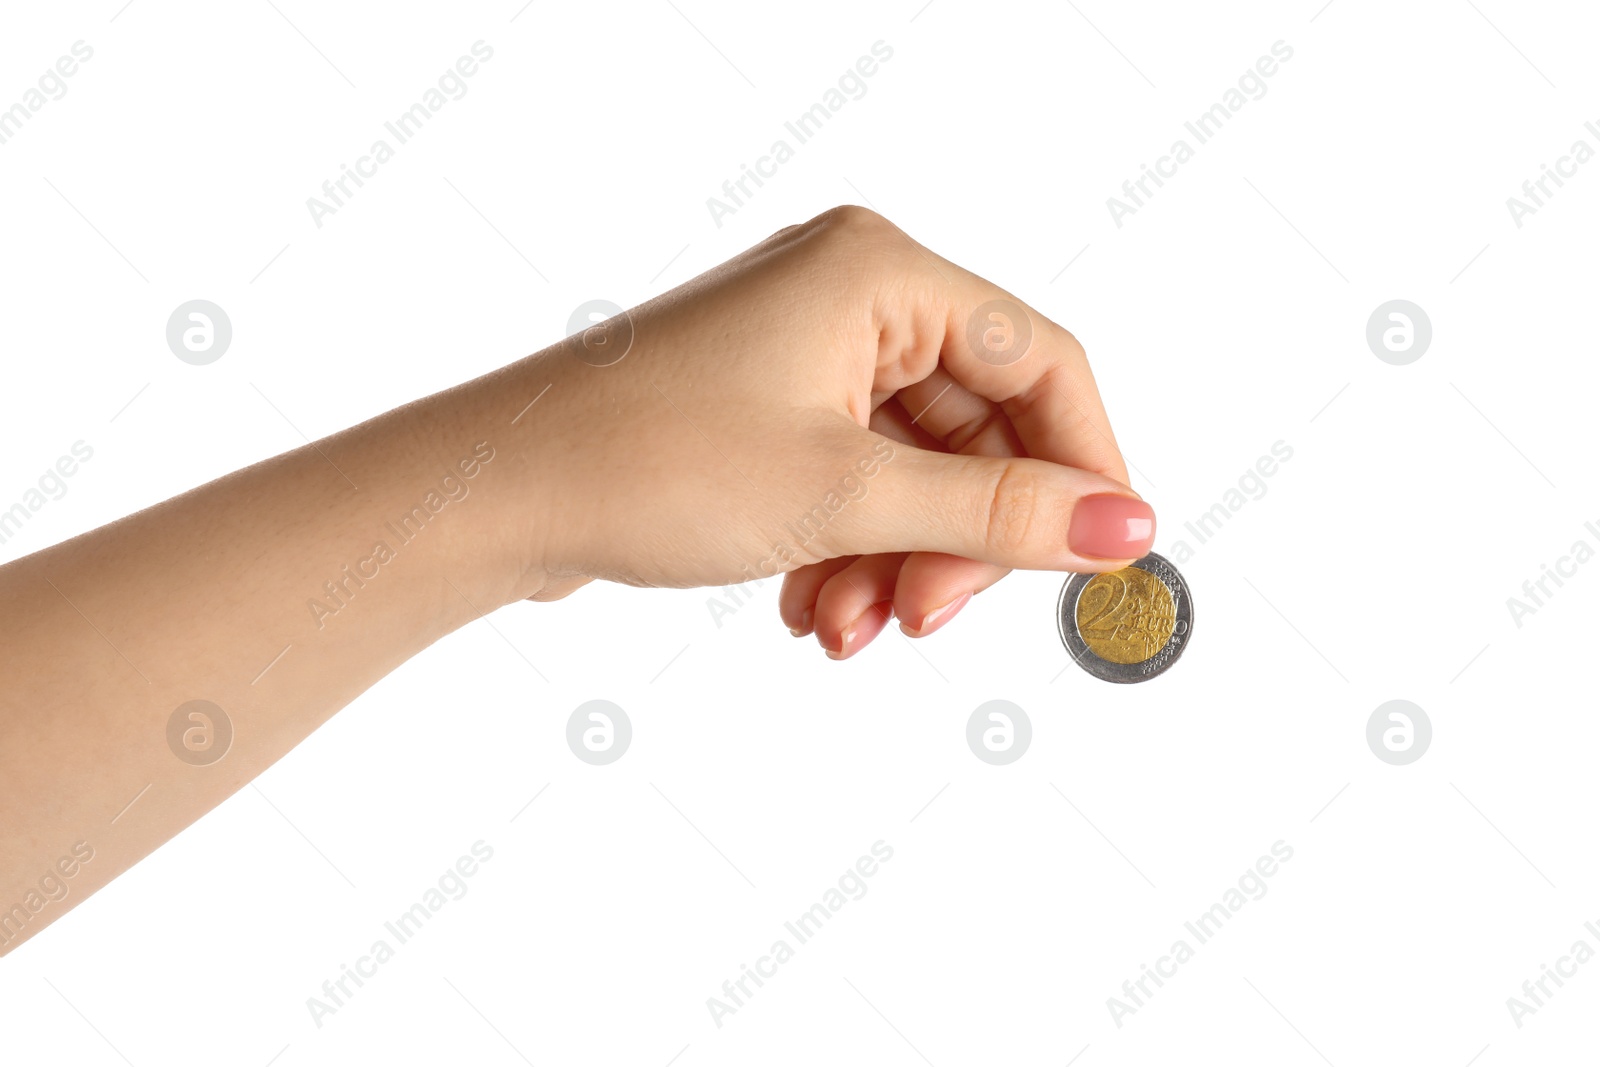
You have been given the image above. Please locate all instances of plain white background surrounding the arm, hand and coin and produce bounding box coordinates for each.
[0,0,1600,1067]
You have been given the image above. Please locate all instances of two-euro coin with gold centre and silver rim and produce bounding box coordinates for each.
[1056,552,1194,681]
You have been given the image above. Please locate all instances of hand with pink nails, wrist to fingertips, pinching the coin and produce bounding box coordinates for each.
[507,208,1155,659]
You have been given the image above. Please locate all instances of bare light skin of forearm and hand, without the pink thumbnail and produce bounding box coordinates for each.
[0,208,1154,953]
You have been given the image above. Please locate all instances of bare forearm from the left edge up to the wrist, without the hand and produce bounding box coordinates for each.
[0,360,542,953]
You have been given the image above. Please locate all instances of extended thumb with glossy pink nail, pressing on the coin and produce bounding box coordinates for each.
[838,445,1155,571]
